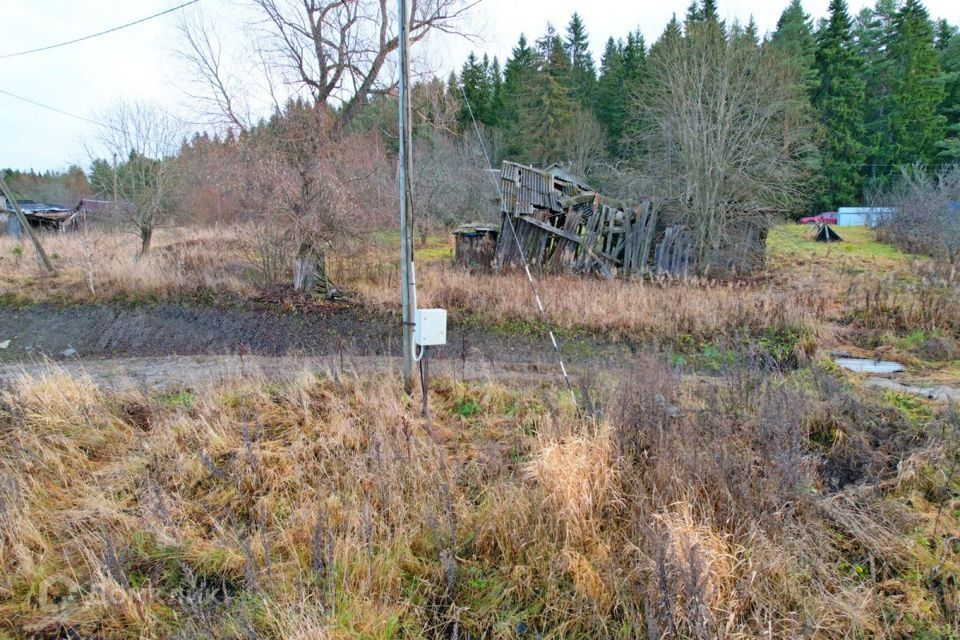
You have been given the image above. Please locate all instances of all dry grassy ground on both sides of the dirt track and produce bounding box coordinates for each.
[0,226,960,640]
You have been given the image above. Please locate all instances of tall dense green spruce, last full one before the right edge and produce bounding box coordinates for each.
[888,0,946,165]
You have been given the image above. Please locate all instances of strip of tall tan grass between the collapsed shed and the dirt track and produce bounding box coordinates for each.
[361,265,828,338]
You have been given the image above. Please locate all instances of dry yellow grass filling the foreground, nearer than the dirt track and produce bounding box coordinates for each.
[0,363,958,638]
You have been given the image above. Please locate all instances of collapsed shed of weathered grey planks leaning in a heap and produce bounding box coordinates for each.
[493,162,766,278]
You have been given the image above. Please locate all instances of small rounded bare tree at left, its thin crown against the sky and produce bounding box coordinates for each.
[99,102,181,256]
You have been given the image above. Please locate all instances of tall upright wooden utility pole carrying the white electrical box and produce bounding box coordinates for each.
[397,0,417,393]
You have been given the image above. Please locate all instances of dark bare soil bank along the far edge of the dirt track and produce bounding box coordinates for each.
[0,300,630,366]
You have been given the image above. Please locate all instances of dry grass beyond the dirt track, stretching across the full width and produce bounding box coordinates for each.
[0,226,960,360]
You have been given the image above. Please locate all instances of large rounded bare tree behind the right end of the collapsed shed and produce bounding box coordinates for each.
[635,22,811,269]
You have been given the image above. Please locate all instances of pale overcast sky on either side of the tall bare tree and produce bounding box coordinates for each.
[0,0,960,171]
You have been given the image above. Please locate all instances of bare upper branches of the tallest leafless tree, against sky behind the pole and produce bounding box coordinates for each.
[181,0,479,130]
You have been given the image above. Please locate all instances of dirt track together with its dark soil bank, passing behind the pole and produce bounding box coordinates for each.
[0,304,633,387]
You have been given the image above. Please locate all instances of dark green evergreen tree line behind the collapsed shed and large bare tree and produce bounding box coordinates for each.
[447,0,960,213]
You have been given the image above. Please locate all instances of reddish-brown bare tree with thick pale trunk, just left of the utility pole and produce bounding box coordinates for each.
[232,103,393,290]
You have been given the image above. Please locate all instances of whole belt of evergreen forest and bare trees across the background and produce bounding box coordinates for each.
[6,0,960,227]
